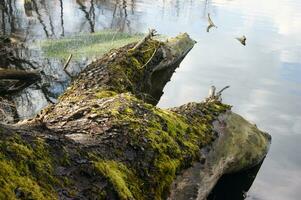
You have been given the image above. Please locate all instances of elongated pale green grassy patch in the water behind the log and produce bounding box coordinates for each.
[38,30,143,60]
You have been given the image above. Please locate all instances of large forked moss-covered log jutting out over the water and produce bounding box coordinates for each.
[0,34,269,200]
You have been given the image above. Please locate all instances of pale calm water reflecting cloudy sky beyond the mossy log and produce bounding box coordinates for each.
[0,0,301,200]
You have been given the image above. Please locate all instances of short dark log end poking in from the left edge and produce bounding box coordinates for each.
[0,68,41,95]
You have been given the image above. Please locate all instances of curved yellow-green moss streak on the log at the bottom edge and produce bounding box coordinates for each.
[94,160,142,200]
